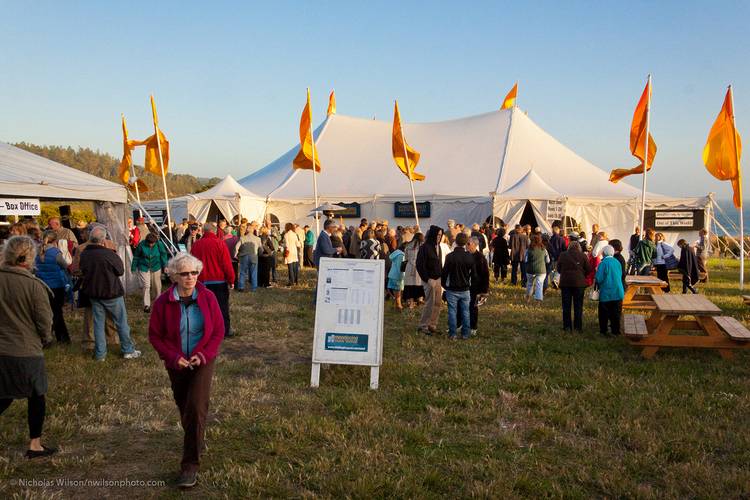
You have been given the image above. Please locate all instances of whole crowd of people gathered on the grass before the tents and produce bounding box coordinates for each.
[0,211,711,487]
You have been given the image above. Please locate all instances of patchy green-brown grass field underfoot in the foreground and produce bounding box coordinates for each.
[0,261,750,498]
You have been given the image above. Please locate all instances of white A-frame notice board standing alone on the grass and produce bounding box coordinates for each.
[310,257,385,389]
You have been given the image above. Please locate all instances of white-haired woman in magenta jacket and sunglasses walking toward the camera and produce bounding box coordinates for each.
[148,253,224,488]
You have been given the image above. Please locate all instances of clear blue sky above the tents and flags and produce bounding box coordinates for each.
[0,0,750,198]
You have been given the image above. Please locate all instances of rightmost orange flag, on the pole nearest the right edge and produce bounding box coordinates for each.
[703,87,742,208]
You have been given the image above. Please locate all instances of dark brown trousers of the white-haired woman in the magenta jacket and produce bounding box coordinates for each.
[167,361,214,472]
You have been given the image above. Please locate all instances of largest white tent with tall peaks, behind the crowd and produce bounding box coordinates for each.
[240,108,710,246]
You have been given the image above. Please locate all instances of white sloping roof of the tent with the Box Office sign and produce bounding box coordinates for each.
[0,142,128,203]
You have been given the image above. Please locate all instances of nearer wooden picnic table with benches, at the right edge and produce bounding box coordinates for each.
[625,294,750,359]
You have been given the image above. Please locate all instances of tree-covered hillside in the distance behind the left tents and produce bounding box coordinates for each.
[15,142,221,200]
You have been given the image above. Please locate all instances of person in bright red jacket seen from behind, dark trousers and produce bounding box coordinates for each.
[190,222,234,337]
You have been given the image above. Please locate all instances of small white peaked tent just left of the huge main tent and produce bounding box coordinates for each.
[143,175,266,222]
